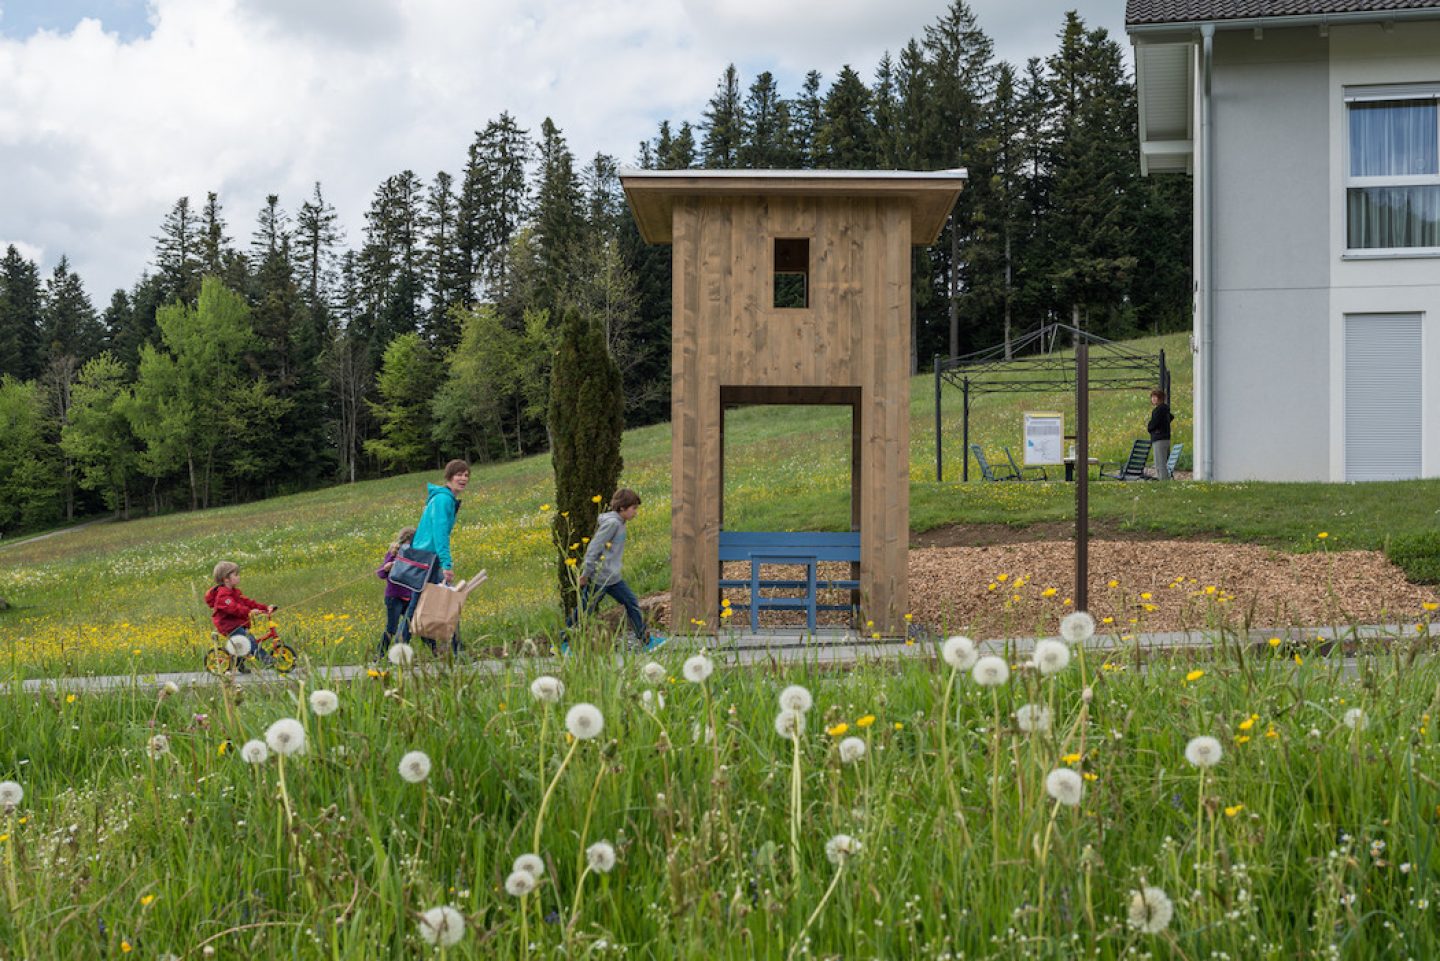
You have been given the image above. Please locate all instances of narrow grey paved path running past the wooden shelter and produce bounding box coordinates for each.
[0,624,1414,693]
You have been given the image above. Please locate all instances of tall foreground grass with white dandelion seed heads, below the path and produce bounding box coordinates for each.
[0,631,1440,961]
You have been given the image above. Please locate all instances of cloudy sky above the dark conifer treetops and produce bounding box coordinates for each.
[0,0,1125,301]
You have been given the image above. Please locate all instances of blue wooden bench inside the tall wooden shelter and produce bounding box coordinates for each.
[720,530,860,631]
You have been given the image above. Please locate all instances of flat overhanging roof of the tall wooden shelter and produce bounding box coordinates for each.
[621,167,968,246]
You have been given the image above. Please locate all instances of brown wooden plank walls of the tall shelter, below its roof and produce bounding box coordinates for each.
[671,196,910,633]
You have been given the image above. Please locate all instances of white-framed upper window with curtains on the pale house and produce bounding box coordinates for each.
[1345,84,1440,252]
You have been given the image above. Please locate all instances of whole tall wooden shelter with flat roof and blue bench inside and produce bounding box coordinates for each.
[621,170,965,633]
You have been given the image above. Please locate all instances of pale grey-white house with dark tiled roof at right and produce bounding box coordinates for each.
[1125,0,1440,481]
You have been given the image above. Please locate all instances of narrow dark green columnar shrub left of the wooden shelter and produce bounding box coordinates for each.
[550,310,625,611]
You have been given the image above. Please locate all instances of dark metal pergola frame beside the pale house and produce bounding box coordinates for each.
[935,324,1169,481]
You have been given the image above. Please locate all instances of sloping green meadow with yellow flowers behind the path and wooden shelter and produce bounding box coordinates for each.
[0,336,1440,676]
